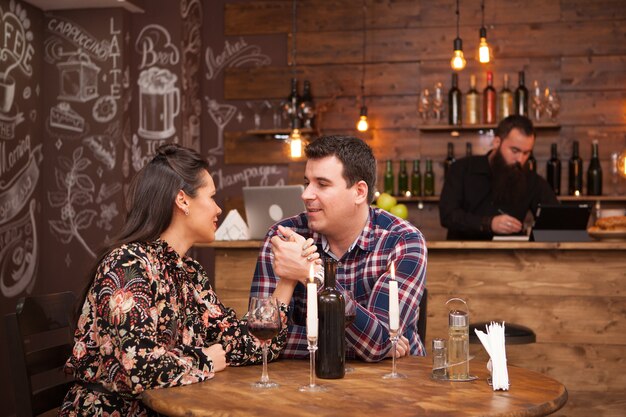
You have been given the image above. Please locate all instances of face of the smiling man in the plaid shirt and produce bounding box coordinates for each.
[302,156,359,236]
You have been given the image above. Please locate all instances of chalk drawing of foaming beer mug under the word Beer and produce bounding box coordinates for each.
[137,67,180,139]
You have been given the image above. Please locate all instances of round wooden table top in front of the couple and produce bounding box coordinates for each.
[143,357,567,417]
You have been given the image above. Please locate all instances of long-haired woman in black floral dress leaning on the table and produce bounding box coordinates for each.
[59,144,310,417]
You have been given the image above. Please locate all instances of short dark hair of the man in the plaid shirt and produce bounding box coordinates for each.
[304,136,376,202]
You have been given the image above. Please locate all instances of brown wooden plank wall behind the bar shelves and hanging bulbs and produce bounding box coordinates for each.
[219,0,626,240]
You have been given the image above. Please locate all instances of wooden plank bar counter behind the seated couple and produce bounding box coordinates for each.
[201,237,626,416]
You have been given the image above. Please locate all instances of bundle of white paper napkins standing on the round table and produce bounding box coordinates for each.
[474,322,509,391]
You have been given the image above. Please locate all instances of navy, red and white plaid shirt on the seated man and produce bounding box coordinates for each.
[250,208,426,362]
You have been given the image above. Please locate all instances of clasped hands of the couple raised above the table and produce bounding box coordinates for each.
[271,226,320,284]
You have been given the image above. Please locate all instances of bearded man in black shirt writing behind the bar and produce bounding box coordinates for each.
[439,115,558,240]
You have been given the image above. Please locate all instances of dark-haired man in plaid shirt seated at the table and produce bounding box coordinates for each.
[250,136,426,362]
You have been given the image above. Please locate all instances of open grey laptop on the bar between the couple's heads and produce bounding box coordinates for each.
[243,185,305,240]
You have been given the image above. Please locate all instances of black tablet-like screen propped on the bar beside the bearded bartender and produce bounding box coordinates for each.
[530,204,591,242]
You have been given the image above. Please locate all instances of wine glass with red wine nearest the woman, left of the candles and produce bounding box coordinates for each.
[247,297,280,389]
